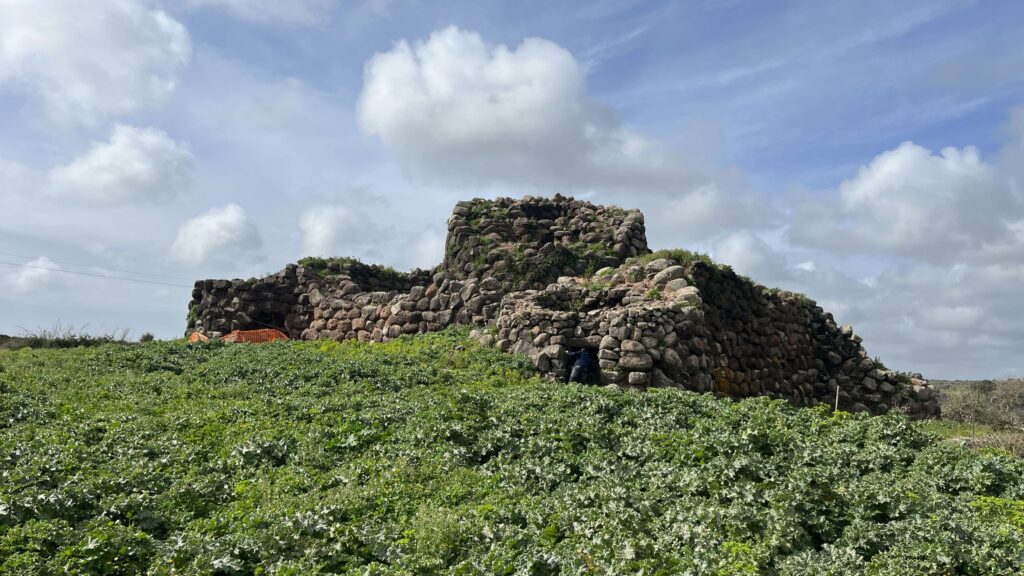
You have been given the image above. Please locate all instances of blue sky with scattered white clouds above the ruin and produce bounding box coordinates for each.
[0,0,1024,378]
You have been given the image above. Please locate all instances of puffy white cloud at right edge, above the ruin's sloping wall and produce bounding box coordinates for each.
[792,142,1024,260]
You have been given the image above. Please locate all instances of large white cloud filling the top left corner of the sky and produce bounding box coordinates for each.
[0,0,191,125]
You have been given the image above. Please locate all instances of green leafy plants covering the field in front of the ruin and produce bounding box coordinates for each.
[0,330,1024,576]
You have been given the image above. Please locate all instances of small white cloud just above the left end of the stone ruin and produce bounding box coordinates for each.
[171,204,262,266]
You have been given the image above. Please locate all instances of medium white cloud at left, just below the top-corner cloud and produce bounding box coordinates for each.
[49,124,193,204]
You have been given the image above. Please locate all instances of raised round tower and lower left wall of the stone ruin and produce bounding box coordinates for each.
[186,196,649,341]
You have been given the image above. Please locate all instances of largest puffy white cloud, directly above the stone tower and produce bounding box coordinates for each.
[357,27,709,192]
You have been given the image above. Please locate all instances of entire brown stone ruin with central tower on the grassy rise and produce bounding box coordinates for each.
[186,196,939,417]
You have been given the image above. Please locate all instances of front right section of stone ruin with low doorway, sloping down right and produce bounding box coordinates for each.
[483,252,938,416]
